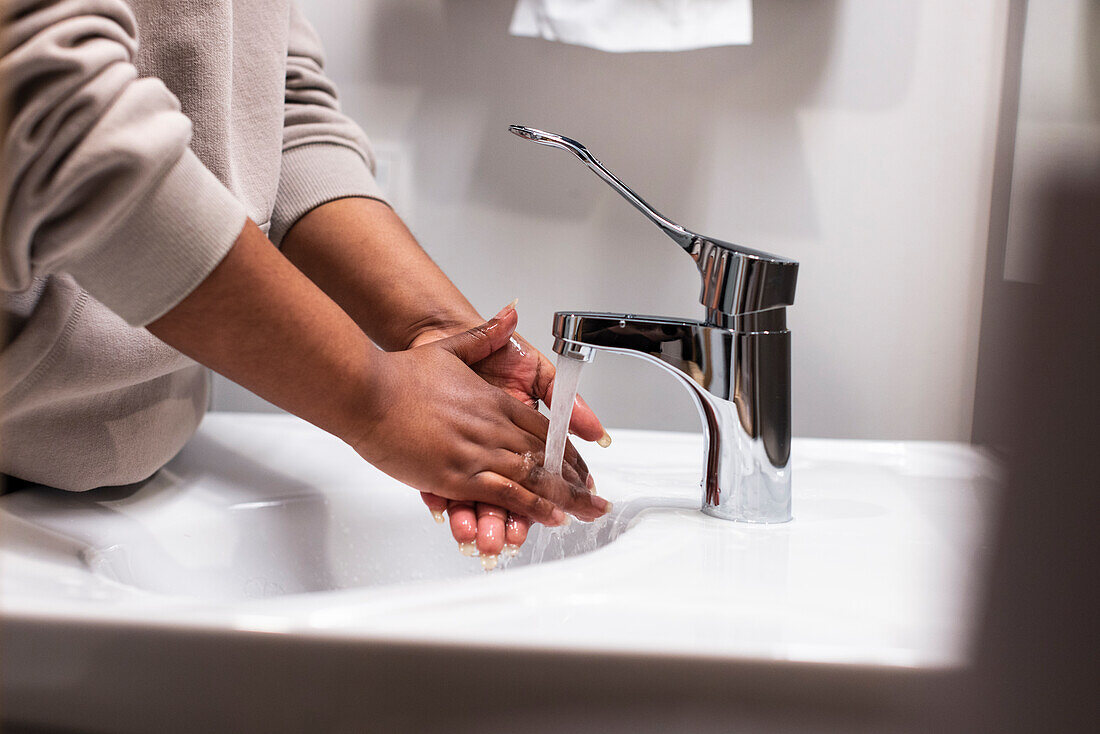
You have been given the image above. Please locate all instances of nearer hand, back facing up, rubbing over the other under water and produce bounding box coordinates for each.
[349,308,609,525]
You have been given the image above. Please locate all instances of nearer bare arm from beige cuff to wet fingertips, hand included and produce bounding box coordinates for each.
[149,222,606,525]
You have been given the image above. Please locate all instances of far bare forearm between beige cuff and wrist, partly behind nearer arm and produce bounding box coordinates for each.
[283,198,482,351]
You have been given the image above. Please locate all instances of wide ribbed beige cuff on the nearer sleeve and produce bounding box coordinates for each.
[68,149,248,326]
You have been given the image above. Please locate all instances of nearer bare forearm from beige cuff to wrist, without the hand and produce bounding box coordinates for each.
[147,221,380,441]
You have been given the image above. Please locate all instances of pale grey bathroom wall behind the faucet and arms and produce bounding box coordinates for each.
[213,0,1008,440]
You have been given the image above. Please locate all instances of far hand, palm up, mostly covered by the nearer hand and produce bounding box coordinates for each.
[413,306,611,557]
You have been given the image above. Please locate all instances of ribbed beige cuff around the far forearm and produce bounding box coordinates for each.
[267,143,386,244]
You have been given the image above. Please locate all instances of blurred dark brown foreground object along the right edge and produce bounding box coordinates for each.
[960,169,1100,732]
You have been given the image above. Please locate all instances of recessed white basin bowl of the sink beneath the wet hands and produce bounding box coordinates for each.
[2,415,646,602]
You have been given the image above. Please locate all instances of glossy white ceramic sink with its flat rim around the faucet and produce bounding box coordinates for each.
[0,414,998,721]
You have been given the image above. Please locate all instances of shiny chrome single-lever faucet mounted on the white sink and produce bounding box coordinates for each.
[509,125,799,523]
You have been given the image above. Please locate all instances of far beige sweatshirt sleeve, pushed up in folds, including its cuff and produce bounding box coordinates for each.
[268,3,385,244]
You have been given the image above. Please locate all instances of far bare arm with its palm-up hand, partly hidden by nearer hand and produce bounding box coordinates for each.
[283,198,608,556]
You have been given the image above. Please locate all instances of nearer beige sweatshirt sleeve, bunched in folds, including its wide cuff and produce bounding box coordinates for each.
[0,0,246,325]
